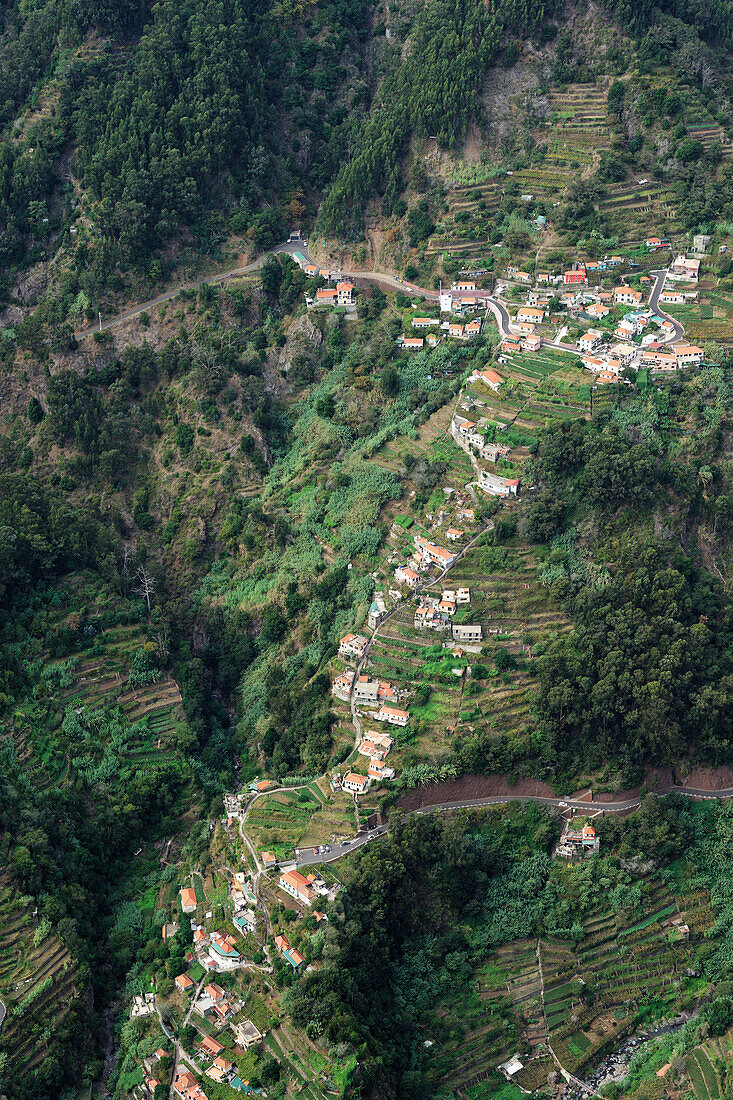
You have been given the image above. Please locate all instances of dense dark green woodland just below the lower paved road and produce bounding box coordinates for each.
[287,795,732,1100]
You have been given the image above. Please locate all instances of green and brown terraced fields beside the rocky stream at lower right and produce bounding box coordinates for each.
[422,865,713,1100]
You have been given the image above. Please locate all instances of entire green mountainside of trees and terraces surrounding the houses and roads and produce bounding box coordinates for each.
[5,0,733,1100]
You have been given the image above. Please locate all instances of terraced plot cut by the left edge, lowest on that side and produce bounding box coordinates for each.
[0,879,78,1076]
